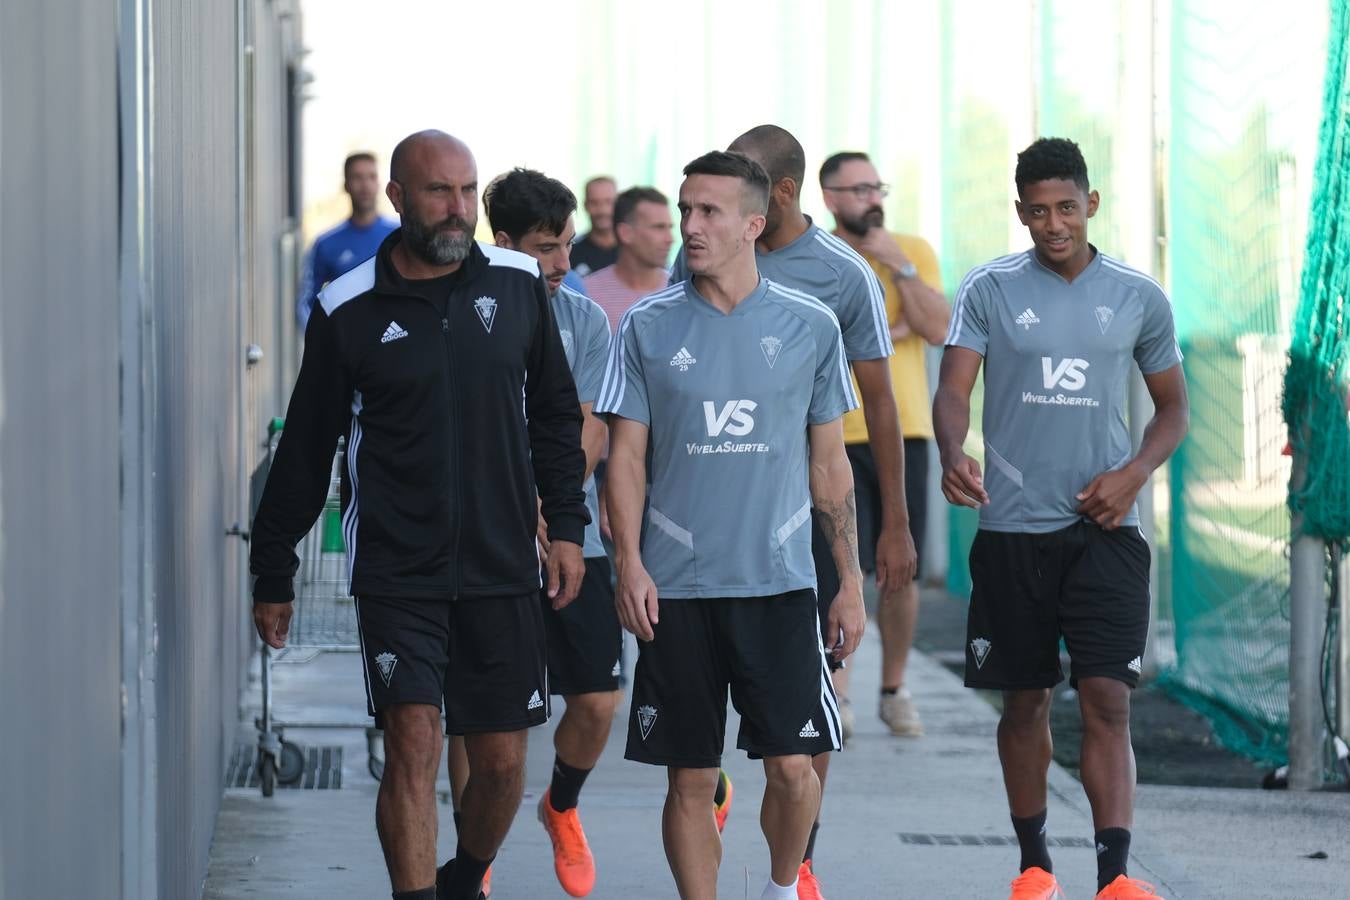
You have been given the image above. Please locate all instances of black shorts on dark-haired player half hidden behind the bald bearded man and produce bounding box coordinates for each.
[539,556,624,696]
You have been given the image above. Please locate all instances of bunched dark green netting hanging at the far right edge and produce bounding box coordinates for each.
[1284,0,1350,542]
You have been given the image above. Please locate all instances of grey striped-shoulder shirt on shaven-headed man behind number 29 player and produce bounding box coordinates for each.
[670,217,895,360]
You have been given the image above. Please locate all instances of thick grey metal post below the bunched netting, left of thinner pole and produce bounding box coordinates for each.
[1289,449,1327,791]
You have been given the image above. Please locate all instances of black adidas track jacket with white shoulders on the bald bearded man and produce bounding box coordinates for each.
[250,231,590,603]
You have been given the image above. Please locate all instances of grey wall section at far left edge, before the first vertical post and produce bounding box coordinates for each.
[0,0,122,900]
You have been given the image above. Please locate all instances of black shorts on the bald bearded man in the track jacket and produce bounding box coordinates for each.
[356,592,549,734]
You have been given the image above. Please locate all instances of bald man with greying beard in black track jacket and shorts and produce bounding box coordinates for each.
[250,131,590,900]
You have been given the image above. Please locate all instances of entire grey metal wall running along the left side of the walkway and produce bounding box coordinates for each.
[0,0,298,900]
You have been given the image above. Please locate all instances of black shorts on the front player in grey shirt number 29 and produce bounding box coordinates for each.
[625,590,840,769]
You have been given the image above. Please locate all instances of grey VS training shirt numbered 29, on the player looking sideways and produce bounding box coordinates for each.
[595,278,857,599]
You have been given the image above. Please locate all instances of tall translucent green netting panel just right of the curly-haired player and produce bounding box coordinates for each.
[1164,0,1343,762]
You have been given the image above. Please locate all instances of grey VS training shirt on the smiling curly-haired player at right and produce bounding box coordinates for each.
[946,250,1181,532]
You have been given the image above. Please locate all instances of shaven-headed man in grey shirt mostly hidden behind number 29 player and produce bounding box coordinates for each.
[671,124,915,897]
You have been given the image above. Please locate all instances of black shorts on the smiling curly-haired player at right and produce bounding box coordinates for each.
[965,519,1150,691]
